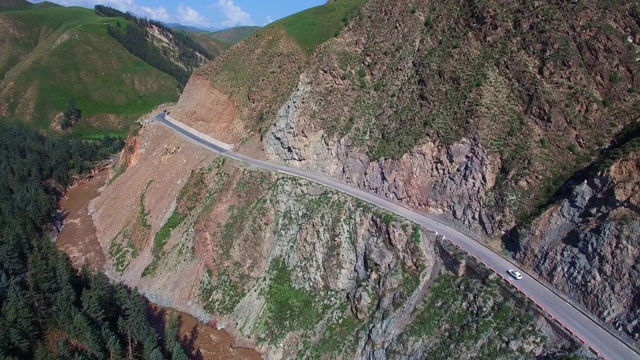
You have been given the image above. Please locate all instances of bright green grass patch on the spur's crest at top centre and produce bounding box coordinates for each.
[277,0,367,54]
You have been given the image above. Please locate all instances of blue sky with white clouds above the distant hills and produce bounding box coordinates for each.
[32,0,326,28]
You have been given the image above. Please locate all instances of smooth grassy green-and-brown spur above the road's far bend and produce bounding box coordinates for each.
[201,0,366,132]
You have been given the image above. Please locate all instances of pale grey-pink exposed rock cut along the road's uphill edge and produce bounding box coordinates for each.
[265,75,499,234]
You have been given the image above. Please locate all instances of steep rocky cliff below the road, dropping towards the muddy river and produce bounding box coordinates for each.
[92,124,575,359]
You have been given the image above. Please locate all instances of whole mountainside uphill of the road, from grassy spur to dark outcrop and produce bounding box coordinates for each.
[165,0,640,354]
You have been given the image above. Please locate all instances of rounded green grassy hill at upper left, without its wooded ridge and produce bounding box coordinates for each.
[0,7,178,135]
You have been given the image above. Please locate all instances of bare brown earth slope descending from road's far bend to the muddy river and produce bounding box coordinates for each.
[91,122,270,354]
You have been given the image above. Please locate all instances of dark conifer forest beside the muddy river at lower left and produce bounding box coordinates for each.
[0,124,187,360]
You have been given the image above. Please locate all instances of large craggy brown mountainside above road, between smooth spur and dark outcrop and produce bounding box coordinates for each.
[263,0,640,235]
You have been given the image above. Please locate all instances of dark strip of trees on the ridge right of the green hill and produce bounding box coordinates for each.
[95,5,213,86]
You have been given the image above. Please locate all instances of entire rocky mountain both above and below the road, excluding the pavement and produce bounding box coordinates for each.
[72,0,640,359]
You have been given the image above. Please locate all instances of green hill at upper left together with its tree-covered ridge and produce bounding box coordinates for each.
[0,1,227,136]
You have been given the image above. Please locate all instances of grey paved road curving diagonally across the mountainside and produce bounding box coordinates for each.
[155,113,640,360]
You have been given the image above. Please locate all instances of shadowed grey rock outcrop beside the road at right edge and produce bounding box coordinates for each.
[515,154,640,340]
